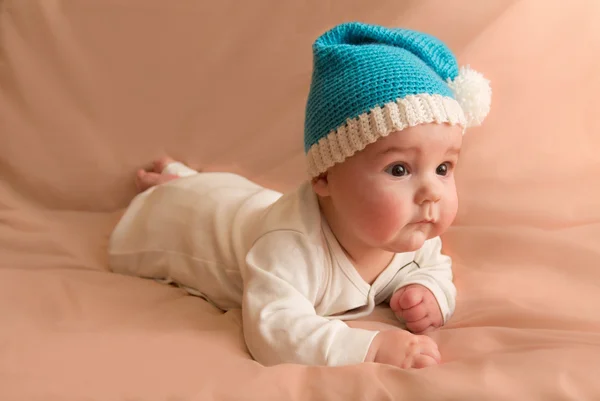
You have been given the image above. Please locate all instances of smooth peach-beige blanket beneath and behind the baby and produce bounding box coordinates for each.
[0,0,600,401]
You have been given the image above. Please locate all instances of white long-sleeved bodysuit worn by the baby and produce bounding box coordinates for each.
[109,163,456,366]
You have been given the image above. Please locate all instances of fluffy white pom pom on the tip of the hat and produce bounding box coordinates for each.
[448,66,492,127]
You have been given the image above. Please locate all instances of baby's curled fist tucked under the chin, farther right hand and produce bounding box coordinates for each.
[390,284,444,334]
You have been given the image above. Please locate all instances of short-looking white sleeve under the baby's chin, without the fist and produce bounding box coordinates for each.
[394,237,456,323]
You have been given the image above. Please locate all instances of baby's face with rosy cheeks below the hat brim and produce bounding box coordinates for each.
[327,124,462,252]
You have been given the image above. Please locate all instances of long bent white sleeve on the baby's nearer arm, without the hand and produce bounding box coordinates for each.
[242,231,378,366]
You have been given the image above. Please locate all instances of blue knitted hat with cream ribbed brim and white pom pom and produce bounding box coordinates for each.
[304,22,491,177]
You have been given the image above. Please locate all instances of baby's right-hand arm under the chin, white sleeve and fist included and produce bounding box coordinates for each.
[390,237,456,333]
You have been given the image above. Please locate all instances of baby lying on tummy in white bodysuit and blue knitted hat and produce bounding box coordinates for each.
[109,23,491,368]
